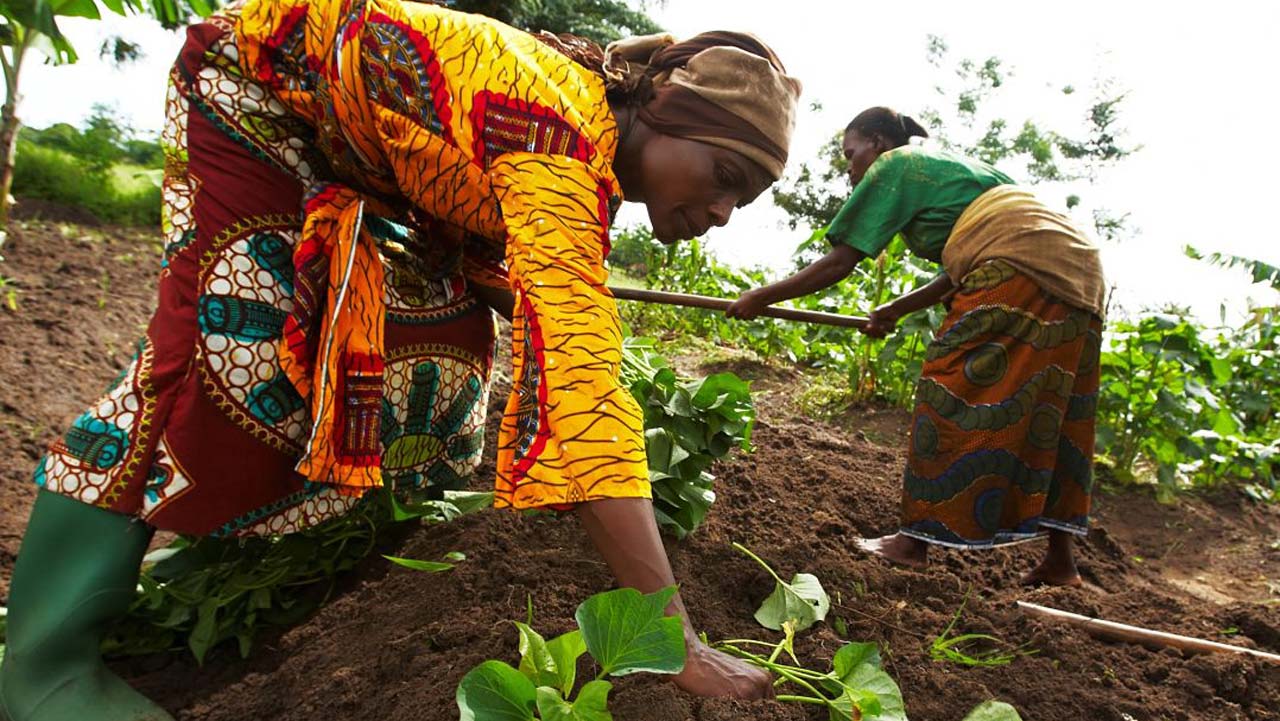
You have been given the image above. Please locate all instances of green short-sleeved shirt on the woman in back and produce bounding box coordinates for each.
[827,146,1014,263]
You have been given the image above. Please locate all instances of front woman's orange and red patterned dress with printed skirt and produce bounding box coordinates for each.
[36,0,649,535]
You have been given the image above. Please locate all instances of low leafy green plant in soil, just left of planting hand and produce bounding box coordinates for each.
[456,587,685,721]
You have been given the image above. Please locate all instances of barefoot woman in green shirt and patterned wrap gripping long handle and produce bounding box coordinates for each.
[728,108,1105,585]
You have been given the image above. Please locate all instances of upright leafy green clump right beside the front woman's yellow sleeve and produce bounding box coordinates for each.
[622,338,755,538]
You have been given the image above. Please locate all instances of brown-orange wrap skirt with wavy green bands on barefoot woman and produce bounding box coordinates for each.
[901,260,1102,547]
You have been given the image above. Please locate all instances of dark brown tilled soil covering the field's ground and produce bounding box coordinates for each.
[0,223,1280,721]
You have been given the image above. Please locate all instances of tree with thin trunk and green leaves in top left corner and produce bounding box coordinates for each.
[0,0,216,239]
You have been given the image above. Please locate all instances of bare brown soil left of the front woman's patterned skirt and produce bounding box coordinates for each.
[0,220,160,595]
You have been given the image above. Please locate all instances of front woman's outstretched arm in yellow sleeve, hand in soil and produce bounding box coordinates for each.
[490,154,773,698]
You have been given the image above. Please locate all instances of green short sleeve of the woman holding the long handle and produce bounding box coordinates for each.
[827,151,922,257]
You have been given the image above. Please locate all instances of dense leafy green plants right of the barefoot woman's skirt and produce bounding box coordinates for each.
[1097,309,1280,499]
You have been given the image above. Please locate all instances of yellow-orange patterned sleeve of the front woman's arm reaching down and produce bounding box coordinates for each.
[489,152,650,510]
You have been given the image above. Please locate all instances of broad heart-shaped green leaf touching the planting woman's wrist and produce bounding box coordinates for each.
[575,587,685,676]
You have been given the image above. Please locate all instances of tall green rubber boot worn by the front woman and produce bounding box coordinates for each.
[0,490,173,721]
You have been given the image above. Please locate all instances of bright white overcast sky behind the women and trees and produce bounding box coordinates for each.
[20,0,1280,315]
